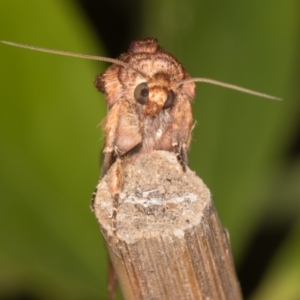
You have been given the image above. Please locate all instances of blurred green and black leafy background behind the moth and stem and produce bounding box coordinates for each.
[0,0,300,300]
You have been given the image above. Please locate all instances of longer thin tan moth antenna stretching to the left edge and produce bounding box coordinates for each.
[1,41,147,80]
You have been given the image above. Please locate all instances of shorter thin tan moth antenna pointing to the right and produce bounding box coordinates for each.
[176,78,282,100]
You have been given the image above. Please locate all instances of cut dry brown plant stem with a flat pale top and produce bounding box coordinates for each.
[95,151,242,300]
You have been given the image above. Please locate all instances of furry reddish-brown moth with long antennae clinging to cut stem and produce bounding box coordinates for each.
[2,39,281,234]
